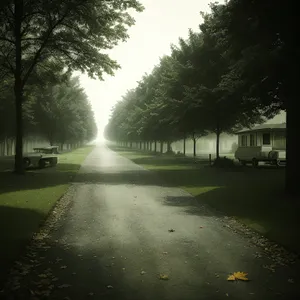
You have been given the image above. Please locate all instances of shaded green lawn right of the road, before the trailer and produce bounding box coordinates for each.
[110,146,300,253]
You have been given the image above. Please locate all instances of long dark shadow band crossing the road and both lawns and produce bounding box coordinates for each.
[0,160,284,194]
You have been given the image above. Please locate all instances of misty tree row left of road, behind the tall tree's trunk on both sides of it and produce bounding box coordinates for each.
[0,76,97,155]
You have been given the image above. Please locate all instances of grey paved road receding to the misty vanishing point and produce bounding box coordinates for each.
[2,146,299,300]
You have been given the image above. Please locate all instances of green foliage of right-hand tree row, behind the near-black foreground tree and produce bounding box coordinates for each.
[106,5,262,156]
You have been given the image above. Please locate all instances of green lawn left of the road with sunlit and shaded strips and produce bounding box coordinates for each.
[0,146,93,282]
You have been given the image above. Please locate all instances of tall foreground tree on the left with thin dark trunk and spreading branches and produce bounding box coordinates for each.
[0,0,143,173]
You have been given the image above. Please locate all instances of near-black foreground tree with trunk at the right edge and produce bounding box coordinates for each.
[219,0,300,195]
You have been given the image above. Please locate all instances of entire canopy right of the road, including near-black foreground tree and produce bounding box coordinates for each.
[106,0,300,194]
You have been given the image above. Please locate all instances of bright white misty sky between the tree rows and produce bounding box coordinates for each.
[80,0,218,141]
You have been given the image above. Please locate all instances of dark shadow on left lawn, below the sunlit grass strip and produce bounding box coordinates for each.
[0,205,45,286]
